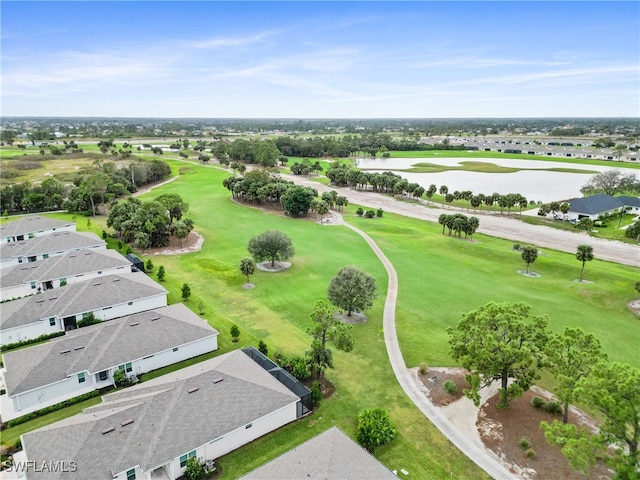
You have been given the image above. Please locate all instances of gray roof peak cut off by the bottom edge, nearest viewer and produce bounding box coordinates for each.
[241,427,398,480]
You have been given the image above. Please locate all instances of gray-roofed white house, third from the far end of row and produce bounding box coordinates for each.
[0,249,131,300]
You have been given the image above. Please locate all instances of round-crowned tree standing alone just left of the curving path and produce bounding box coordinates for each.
[327,266,377,316]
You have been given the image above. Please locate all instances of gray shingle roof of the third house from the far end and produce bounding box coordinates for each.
[0,249,131,288]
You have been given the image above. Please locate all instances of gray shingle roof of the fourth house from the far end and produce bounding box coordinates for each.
[0,273,167,330]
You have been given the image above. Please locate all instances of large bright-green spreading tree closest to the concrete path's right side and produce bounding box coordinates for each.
[447,302,547,408]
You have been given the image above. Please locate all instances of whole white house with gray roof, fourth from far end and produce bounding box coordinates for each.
[0,273,167,345]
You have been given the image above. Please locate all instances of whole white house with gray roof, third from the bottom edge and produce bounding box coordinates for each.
[0,303,218,421]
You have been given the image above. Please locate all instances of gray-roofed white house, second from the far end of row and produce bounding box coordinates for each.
[0,232,107,268]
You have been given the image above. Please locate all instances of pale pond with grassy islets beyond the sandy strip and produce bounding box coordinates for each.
[357,157,613,203]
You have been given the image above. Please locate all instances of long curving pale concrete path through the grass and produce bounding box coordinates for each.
[332,212,520,480]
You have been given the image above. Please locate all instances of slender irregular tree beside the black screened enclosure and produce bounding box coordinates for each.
[307,300,355,379]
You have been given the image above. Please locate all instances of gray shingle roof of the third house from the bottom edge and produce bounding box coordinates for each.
[4,303,218,396]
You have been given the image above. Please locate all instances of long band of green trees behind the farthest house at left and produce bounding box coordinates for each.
[0,159,171,215]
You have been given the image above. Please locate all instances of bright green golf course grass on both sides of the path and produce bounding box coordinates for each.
[2,153,640,479]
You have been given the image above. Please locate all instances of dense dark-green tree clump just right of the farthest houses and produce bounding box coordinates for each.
[107,193,193,248]
